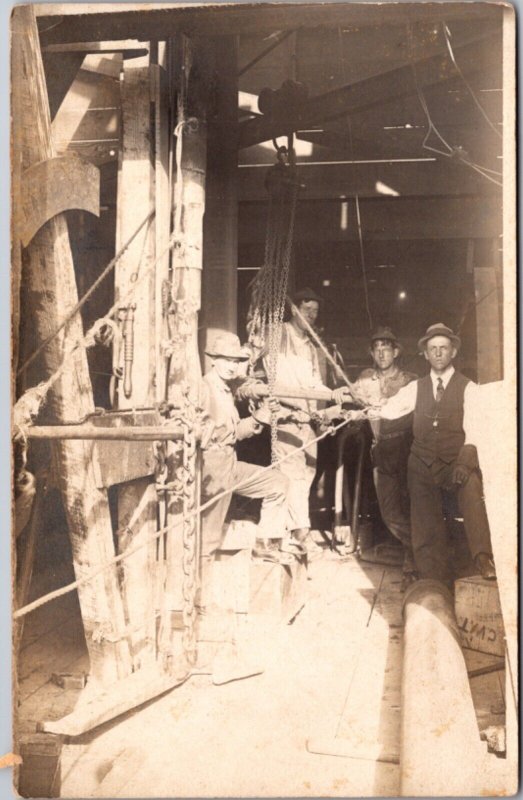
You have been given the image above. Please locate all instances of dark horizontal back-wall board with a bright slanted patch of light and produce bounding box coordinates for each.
[238,159,500,202]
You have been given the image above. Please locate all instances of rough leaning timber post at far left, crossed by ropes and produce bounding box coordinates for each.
[12,6,131,684]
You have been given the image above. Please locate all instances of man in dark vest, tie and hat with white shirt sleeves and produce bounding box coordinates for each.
[379,323,496,585]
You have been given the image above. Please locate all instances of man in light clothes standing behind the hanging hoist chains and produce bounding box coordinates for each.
[275,288,347,556]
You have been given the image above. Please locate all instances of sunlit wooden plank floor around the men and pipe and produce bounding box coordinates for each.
[19,551,504,797]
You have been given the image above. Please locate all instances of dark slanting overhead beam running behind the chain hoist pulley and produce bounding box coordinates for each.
[239,34,500,148]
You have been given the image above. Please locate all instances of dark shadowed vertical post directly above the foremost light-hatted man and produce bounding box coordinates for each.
[202,36,239,366]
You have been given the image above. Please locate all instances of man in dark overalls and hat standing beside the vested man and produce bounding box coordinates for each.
[355,327,418,584]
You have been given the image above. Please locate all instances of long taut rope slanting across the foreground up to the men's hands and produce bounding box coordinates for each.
[13,419,351,619]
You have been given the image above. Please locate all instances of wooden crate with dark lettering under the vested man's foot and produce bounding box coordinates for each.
[454,576,505,656]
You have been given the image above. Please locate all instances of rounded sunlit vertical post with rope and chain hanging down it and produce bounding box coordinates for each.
[160,35,210,670]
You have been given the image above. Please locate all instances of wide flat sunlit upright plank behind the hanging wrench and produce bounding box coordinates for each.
[115,61,160,670]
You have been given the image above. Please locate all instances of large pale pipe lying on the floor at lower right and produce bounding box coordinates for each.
[400,579,488,797]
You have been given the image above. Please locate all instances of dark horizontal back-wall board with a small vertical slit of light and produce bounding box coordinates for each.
[238,197,501,244]
